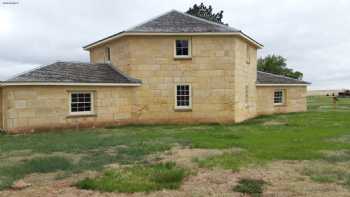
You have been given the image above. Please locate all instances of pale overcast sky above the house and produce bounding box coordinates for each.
[0,0,350,89]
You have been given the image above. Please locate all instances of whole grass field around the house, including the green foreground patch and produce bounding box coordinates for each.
[0,97,350,195]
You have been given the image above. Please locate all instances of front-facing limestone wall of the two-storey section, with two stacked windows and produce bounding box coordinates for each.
[124,36,235,123]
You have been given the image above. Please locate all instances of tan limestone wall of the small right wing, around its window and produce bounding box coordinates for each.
[257,86,307,115]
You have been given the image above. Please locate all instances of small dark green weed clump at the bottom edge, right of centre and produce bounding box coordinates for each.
[233,179,266,197]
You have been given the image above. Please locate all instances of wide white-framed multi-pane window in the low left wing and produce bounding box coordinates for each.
[70,92,93,115]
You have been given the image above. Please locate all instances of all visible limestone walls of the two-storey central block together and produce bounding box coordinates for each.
[90,36,266,122]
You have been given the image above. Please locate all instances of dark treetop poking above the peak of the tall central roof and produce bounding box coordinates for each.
[186,3,228,25]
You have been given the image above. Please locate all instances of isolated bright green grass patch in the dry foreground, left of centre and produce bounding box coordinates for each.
[76,163,187,193]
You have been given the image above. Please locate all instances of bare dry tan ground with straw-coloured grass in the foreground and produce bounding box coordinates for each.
[0,149,350,197]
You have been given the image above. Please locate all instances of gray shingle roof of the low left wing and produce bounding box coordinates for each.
[4,62,141,83]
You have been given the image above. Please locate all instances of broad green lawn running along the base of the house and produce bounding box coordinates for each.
[0,97,350,191]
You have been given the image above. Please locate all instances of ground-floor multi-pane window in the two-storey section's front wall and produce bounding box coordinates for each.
[175,84,192,109]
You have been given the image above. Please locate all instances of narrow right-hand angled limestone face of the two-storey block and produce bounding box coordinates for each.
[234,38,257,122]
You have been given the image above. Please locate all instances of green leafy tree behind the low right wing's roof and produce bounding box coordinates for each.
[257,55,303,80]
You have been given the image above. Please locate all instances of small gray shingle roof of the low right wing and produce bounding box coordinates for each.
[256,71,310,85]
